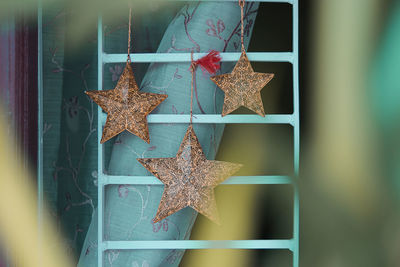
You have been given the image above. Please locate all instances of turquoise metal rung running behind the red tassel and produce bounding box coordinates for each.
[103,52,293,63]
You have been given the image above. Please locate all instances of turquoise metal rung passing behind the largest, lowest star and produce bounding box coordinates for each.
[99,174,293,185]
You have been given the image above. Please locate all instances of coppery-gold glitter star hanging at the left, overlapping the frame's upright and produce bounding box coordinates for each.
[85,62,168,144]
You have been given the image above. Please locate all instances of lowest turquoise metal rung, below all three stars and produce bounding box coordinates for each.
[102,239,294,251]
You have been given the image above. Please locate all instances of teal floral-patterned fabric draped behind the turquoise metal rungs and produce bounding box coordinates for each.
[43,2,258,267]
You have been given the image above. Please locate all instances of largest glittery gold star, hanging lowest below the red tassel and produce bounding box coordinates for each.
[137,125,242,223]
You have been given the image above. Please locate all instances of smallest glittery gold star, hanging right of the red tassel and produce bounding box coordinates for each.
[210,50,274,117]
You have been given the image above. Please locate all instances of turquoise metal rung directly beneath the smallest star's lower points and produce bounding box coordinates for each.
[101,112,295,125]
